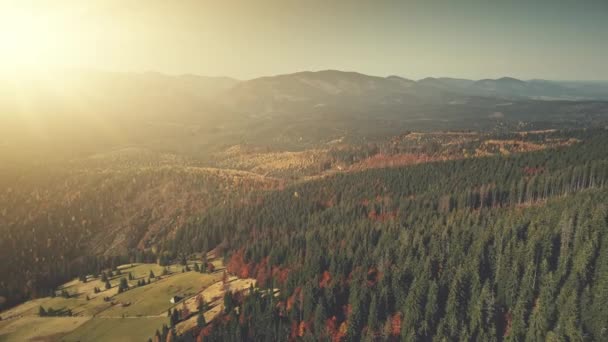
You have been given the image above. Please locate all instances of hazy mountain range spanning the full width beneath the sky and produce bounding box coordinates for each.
[0,70,608,163]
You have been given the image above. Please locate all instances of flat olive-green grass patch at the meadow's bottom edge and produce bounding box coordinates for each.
[62,317,168,342]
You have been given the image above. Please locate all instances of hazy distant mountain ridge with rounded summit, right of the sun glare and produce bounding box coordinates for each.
[215,70,608,117]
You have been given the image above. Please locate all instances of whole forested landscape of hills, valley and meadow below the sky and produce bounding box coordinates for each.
[0,71,608,342]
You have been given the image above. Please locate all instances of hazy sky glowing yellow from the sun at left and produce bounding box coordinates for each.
[0,0,608,80]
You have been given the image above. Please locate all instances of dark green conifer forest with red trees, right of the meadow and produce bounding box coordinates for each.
[167,130,608,341]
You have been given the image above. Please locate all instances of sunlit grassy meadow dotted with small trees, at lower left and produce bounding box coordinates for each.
[0,259,228,342]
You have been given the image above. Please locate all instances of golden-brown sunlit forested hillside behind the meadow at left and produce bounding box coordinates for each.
[0,158,278,304]
